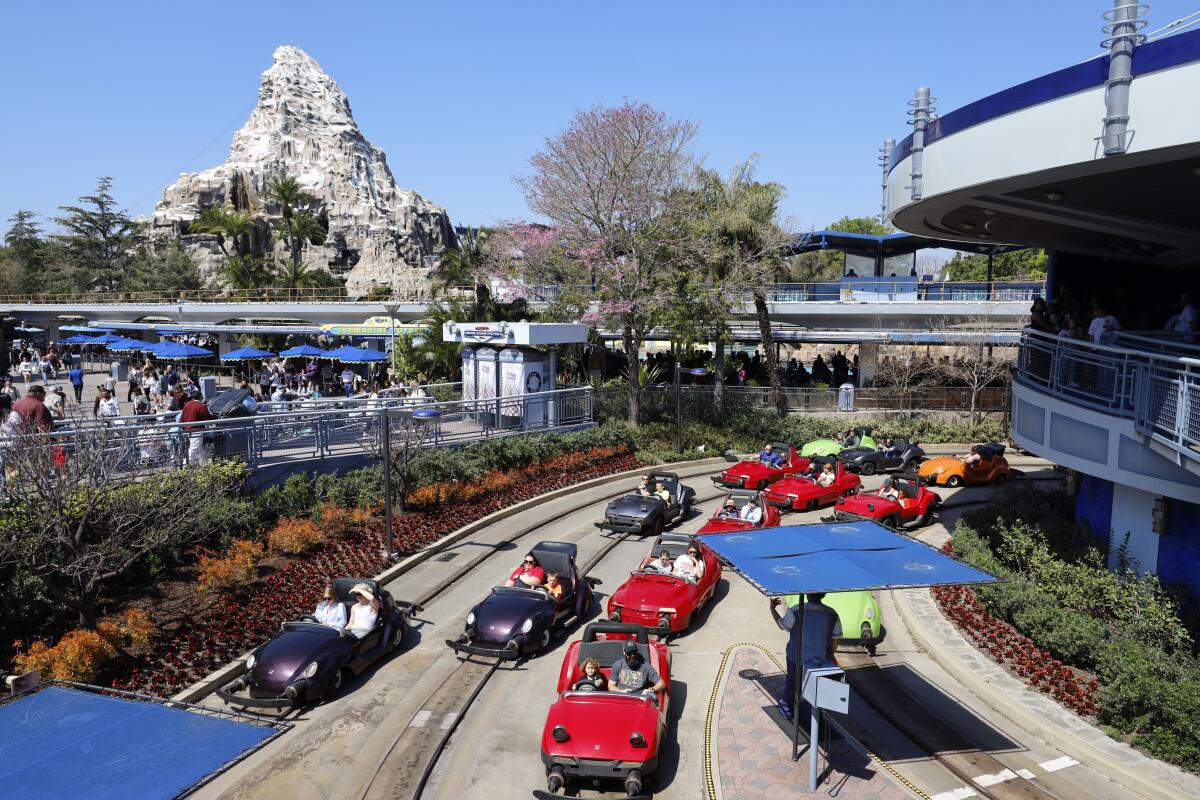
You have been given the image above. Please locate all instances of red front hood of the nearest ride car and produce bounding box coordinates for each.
[541,692,661,762]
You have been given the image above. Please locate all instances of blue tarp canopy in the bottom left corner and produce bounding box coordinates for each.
[0,686,275,800]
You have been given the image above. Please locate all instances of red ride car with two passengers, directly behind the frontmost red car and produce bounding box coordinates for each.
[608,534,721,636]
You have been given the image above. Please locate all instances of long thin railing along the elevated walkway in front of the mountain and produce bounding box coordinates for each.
[0,277,1045,306]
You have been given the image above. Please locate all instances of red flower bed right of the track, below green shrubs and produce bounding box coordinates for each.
[934,542,1100,716]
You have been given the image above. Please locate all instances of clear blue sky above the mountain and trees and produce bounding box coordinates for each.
[0,0,1200,235]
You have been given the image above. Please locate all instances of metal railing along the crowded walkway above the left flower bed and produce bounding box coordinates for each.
[41,386,594,471]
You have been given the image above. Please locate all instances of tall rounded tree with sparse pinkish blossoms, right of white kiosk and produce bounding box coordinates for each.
[517,101,697,426]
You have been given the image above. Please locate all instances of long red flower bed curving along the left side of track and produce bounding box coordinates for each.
[113,453,638,697]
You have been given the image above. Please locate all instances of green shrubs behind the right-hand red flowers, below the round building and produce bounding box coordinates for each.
[953,486,1200,771]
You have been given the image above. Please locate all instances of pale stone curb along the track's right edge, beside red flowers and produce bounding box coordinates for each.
[892,589,1198,800]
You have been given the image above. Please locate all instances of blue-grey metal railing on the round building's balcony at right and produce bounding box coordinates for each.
[1016,330,1200,463]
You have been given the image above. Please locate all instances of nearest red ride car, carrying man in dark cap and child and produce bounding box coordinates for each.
[534,622,671,798]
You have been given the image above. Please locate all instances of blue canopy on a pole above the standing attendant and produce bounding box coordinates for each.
[702,522,998,596]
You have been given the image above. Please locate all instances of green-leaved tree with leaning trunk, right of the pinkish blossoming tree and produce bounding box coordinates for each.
[698,156,791,414]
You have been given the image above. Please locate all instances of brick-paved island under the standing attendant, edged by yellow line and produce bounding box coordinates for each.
[714,648,910,800]
